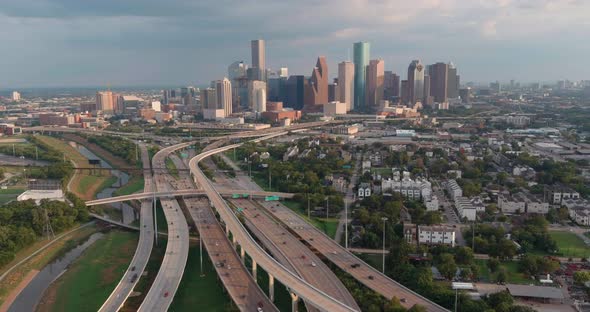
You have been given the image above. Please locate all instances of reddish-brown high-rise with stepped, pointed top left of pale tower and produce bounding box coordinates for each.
[305,56,328,112]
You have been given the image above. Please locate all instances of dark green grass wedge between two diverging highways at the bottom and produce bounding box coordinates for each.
[170,243,233,312]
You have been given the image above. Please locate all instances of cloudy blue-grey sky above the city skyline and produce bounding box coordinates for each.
[0,0,590,88]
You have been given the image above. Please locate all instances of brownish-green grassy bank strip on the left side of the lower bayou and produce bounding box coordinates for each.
[0,226,96,304]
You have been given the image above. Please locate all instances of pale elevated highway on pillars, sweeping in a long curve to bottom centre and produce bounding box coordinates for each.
[189,131,356,311]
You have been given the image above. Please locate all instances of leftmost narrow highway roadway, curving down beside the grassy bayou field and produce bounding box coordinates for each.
[99,144,154,312]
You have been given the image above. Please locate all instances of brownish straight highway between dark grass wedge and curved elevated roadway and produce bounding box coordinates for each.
[170,155,278,311]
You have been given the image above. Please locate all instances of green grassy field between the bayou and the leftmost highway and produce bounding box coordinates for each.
[38,231,138,312]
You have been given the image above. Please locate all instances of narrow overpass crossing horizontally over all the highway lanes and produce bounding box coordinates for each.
[86,189,295,206]
